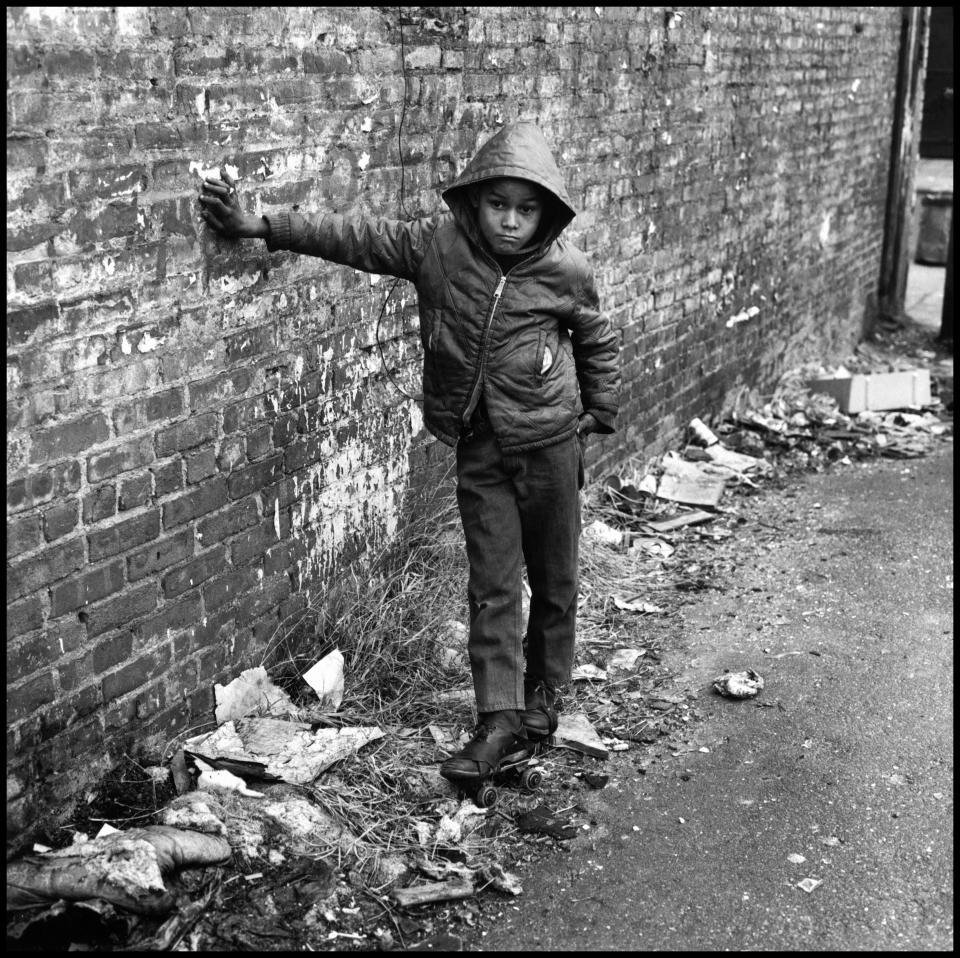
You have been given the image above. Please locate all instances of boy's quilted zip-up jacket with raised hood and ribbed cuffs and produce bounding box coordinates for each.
[264,123,620,453]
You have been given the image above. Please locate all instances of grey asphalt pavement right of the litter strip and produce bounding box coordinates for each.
[464,441,953,951]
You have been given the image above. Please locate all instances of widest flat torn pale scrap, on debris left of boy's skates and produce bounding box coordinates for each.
[183,718,383,785]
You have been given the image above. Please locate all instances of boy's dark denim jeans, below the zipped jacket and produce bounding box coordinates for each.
[457,431,583,712]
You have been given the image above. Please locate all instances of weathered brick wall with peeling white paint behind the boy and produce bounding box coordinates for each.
[6,6,901,831]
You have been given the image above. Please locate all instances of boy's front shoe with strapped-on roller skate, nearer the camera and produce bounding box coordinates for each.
[440,712,543,808]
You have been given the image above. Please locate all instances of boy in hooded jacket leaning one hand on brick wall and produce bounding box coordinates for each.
[200,122,620,782]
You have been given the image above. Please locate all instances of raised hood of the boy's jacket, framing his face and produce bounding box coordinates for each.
[440,122,577,248]
